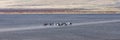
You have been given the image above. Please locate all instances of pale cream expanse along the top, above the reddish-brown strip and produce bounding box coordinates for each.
[0,0,120,8]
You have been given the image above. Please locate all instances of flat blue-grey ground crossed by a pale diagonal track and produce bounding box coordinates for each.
[0,14,120,40]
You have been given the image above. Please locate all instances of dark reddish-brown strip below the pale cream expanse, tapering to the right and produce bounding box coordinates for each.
[0,8,91,12]
